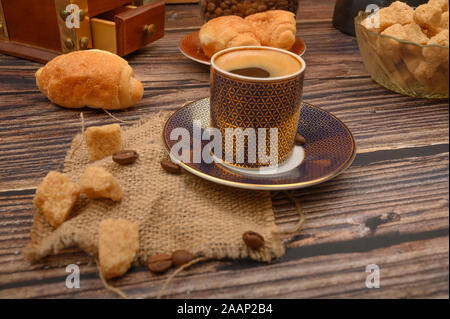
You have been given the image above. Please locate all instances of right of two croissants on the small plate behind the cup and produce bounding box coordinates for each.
[245,10,297,50]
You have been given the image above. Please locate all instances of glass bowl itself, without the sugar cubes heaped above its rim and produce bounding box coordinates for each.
[355,11,449,99]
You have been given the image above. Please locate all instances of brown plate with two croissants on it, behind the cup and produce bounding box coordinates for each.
[179,10,306,65]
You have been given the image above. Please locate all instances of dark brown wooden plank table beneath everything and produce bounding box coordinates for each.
[0,0,449,298]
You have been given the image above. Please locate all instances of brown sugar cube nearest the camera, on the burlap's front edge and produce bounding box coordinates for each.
[98,218,139,278]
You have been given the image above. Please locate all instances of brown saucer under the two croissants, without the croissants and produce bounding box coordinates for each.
[178,31,306,65]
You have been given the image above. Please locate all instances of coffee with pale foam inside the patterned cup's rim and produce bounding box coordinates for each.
[214,49,302,78]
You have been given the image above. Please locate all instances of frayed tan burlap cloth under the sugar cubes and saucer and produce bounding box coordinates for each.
[25,113,285,265]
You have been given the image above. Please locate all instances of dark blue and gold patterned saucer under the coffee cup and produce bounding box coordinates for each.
[162,98,356,190]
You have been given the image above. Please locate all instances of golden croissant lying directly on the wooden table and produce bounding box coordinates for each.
[35,50,143,110]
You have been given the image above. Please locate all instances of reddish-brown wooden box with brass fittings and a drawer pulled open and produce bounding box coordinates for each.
[0,0,165,63]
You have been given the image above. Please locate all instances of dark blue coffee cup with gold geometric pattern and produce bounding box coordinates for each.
[210,47,306,168]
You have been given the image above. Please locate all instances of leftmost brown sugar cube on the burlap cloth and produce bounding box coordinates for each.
[33,171,80,228]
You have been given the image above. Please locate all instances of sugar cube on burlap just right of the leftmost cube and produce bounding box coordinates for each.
[80,166,122,202]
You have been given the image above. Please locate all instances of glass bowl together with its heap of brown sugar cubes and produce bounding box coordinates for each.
[355,0,449,99]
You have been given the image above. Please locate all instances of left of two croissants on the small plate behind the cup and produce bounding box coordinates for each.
[199,16,261,58]
